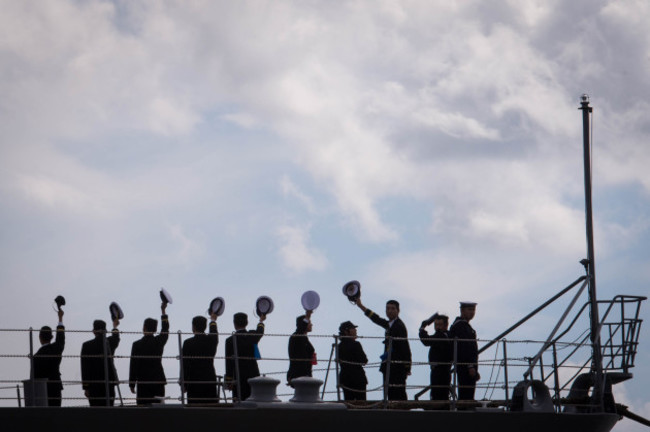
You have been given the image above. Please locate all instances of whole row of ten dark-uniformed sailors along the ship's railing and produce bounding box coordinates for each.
[33,297,480,406]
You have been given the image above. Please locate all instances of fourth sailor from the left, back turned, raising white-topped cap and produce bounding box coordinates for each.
[181,311,219,405]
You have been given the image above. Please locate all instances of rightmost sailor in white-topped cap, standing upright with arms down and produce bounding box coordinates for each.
[449,302,481,400]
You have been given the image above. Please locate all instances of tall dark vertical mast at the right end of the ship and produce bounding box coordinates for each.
[579,94,603,406]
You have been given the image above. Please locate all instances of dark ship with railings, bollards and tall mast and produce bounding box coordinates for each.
[0,95,650,432]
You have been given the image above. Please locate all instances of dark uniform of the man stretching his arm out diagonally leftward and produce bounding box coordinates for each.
[364,309,411,400]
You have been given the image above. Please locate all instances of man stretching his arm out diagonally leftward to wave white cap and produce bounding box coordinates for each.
[355,298,411,400]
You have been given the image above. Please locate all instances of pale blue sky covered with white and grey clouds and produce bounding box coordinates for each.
[0,0,650,431]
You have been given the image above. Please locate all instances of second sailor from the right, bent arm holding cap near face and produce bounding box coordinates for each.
[419,313,454,401]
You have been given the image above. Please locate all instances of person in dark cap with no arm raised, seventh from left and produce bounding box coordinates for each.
[338,321,368,401]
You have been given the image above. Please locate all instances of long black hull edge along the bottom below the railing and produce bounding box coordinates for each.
[0,406,619,432]
